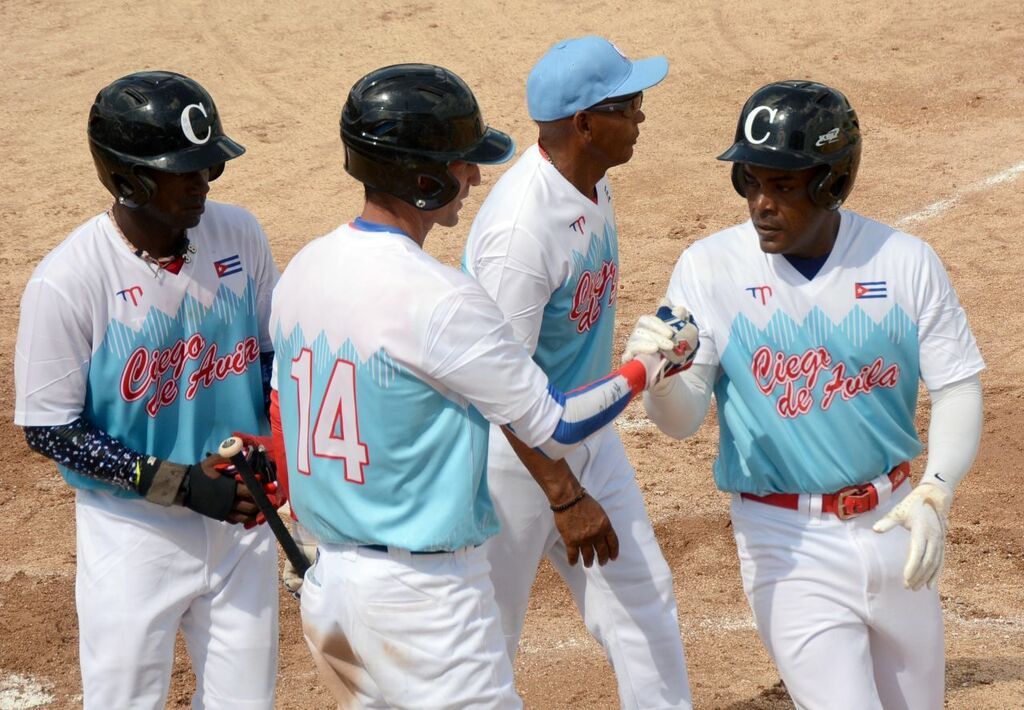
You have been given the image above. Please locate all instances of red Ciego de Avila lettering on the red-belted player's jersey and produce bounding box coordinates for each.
[751,345,899,419]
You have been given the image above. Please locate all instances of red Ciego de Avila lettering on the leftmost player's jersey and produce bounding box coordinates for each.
[121,333,259,417]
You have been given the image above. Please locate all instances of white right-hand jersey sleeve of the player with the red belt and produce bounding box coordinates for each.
[918,243,985,389]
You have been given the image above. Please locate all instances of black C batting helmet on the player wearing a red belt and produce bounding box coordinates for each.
[718,81,860,210]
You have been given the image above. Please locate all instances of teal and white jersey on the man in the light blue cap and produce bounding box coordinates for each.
[463,144,618,391]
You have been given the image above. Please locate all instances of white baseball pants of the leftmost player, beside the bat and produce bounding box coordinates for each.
[75,490,278,710]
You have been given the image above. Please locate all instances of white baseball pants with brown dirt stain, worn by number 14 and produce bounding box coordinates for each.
[302,543,522,710]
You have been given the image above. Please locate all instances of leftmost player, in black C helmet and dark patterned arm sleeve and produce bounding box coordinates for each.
[14,72,278,710]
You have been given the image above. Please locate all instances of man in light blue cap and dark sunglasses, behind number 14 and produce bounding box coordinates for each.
[463,36,692,708]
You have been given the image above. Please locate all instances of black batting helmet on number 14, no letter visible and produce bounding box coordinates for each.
[341,65,515,210]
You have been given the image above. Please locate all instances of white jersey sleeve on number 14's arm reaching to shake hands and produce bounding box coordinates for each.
[423,282,561,446]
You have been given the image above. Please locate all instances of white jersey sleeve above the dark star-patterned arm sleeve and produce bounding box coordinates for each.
[14,275,92,426]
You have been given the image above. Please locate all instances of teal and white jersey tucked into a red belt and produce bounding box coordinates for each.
[668,210,984,495]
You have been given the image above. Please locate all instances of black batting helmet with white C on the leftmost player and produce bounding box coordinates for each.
[89,72,246,207]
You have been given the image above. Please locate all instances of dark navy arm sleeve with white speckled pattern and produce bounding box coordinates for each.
[25,417,144,491]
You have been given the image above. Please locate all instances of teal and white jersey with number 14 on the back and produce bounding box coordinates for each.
[270,220,561,551]
